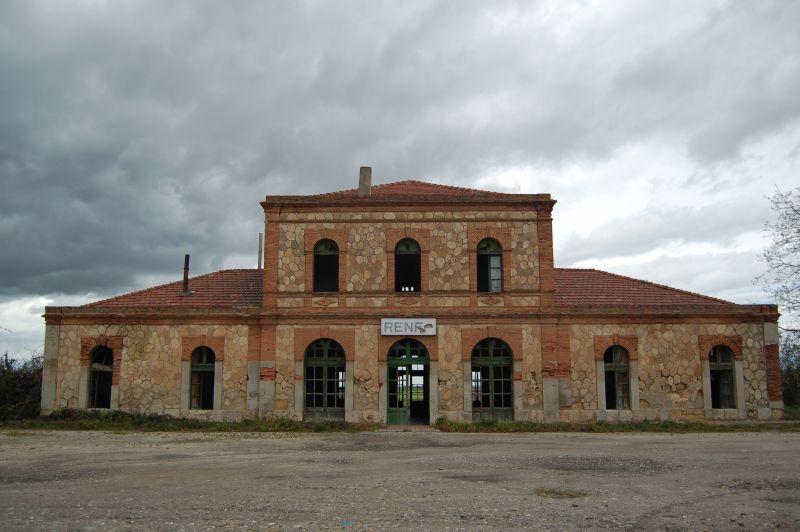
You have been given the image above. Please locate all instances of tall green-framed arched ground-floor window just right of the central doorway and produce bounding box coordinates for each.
[472,338,514,421]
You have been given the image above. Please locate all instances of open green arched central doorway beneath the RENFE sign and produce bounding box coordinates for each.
[386,338,430,425]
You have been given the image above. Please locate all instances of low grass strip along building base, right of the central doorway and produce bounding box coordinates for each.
[436,418,800,434]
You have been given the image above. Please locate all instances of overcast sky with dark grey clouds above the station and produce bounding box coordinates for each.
[0,0,800,356]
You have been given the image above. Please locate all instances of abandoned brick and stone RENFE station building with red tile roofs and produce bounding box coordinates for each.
[42,167,783,424]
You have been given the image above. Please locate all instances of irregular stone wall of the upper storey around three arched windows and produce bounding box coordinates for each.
[277,212,539,296]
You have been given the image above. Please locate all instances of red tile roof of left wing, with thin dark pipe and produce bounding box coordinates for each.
[84,270,264,308]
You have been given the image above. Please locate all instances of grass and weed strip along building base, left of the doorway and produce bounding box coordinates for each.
[0,409,382,434]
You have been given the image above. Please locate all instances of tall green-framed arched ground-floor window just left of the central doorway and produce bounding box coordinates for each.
[303,338,345,421]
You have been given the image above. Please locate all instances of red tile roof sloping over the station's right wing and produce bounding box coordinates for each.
[555,268,734,307]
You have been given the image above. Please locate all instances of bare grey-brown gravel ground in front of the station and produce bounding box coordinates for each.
[0,431,800,530]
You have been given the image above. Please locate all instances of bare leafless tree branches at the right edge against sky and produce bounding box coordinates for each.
[759,188,800,328]
